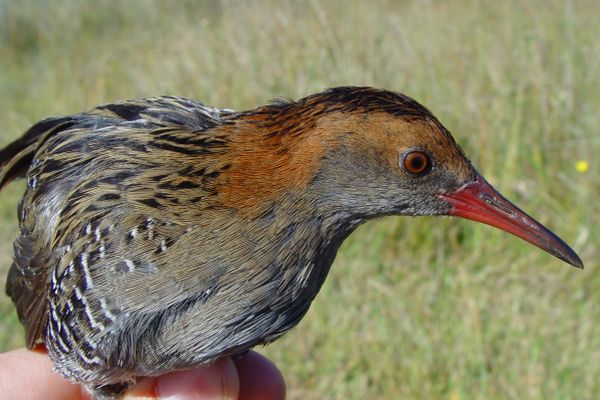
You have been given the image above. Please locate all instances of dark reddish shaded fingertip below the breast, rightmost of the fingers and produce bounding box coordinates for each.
[234,351,285,400]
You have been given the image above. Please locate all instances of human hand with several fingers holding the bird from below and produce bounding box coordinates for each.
[0,349,285,400]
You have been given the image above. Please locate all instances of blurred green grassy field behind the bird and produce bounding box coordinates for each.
[0,0,600,400]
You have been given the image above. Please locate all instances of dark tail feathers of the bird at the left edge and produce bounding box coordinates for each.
[0,117,75,190]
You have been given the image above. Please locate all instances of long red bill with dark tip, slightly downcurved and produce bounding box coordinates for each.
[440,174,583,268]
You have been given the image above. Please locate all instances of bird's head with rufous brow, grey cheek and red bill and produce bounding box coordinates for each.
[256,87,583,268]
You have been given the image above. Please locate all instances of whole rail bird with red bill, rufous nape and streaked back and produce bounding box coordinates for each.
[0,86,583,399]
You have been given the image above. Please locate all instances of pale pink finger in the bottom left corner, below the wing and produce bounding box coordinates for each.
[0,349,83,400]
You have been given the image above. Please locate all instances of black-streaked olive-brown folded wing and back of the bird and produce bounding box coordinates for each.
[6,97,237,347]
